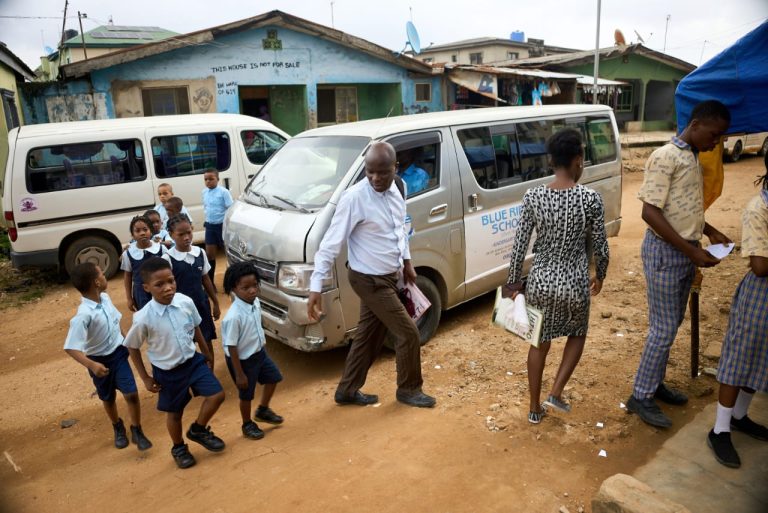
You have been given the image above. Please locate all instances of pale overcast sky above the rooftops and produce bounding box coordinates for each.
[0,0,768,69]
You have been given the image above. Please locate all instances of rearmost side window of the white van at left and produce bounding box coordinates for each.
[26,139,147,193]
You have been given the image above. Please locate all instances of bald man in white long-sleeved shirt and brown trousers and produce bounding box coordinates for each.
[307,142,435,408]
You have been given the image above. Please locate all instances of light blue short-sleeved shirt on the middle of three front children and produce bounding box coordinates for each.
[123,292,202,370]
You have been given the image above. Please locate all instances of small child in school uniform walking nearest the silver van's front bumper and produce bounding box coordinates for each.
[221,262,283,440]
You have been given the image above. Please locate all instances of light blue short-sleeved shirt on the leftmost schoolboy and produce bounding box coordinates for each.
[64,292,123,356]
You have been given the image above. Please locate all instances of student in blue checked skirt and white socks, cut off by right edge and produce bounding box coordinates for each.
[707,155,768,468]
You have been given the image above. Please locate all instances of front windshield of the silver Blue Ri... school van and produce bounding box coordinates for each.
[244,136,370,213]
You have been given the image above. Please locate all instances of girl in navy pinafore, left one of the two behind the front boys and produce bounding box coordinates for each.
[120,216,166,312]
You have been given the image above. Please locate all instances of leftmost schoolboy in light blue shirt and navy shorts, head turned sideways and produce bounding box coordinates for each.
[64,262,152,451]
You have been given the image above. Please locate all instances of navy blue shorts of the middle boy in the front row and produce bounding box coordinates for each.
[152,353,223,413]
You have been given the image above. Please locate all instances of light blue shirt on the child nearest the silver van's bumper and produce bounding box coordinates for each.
[221,296,266,360]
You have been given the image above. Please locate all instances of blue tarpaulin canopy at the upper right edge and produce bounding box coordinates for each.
[675,20,768,134]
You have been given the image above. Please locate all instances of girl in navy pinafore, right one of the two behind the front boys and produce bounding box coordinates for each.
[163,214,220,348]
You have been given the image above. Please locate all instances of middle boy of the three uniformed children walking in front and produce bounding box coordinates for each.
[124,257,225,468]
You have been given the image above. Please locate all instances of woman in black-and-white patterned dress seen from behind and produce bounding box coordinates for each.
[503,128,608,424]
